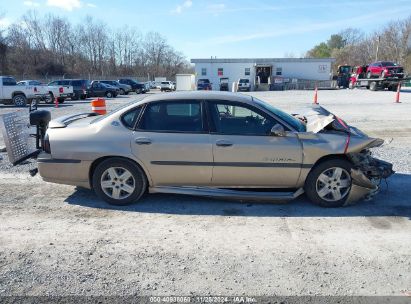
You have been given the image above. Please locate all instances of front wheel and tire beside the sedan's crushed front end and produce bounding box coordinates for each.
[304,159,352,208]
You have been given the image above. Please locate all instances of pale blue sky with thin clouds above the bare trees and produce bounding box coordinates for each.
[0,0,411,59]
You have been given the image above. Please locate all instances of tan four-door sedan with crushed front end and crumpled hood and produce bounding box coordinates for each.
[34,92,394,207]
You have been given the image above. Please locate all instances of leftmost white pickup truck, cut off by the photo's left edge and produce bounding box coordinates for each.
[0,76,42,107]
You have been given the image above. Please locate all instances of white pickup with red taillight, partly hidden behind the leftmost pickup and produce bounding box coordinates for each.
[17,80,73,103]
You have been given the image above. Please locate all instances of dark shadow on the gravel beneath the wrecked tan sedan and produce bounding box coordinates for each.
[65,174,411,219]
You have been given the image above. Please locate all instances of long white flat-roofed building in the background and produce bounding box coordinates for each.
[191,58,335,90]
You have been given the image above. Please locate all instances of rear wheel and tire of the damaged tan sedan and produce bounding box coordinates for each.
[92,157,147,206]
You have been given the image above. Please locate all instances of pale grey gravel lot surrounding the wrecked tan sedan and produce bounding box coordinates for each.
[0,90,411,296]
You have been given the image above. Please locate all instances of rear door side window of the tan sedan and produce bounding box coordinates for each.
[140,100,203,133]
